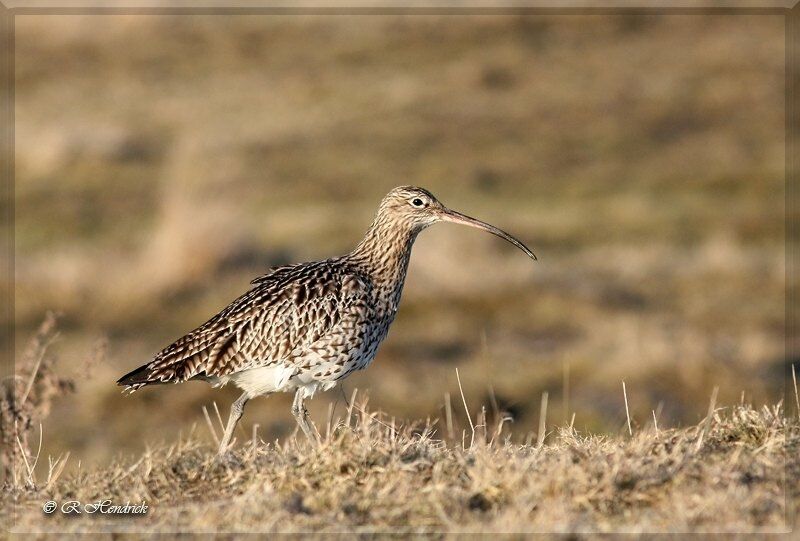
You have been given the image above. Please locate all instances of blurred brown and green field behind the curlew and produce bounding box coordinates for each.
[6,14,790,464]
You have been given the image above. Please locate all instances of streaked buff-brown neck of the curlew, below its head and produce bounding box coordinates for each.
[350,216,419,294]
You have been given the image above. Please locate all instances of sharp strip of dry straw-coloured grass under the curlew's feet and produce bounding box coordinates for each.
[5,390,800,533]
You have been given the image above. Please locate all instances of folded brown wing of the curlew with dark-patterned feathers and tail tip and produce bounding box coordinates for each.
[117,262,371,390]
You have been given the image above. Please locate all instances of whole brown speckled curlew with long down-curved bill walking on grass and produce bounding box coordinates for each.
[117,186,536,455]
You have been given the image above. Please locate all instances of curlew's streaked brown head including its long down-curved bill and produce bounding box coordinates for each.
[376,186,536,260]
